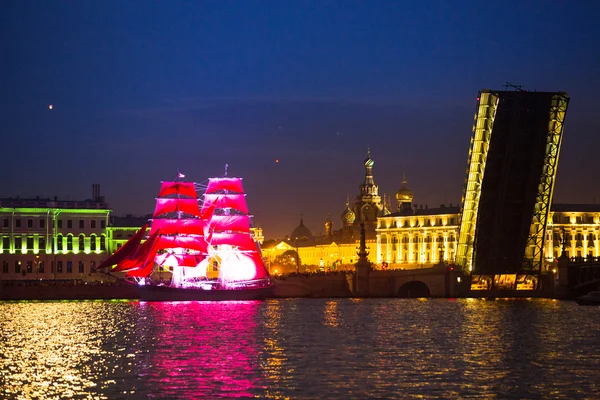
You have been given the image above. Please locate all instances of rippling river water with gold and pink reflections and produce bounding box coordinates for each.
[0,299,600,399]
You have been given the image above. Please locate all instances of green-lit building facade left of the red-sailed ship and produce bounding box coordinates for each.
[0,191,110,280]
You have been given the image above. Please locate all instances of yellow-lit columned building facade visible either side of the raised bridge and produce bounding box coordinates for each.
[377,204,600,272]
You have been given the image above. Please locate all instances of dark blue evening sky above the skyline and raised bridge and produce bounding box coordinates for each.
[0,0,600,237]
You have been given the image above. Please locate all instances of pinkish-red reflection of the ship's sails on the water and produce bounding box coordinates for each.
[140,301,260,398]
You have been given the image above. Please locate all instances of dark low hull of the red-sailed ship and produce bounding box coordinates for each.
[138,285,272,301]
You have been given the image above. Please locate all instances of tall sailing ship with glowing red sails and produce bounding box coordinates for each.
[98,168,272,301]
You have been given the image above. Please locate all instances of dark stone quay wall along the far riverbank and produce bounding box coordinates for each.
[0,264,572,300]
